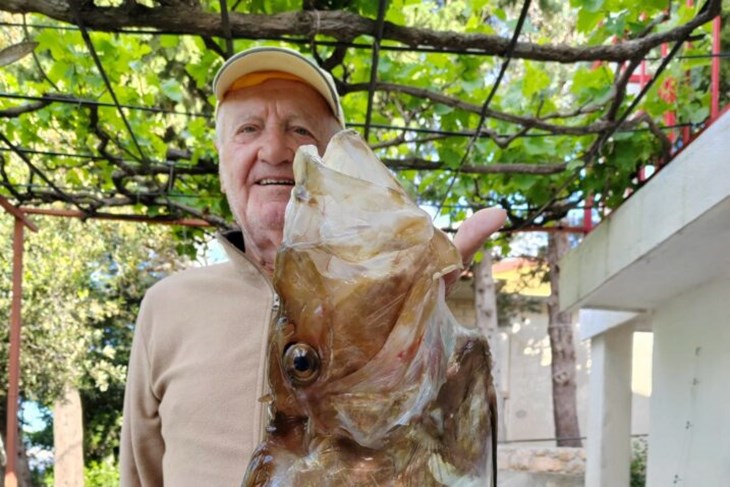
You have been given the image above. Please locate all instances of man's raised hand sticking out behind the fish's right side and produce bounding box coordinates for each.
[444,208,507,295]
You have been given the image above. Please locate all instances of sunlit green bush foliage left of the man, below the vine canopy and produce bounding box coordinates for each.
[0,216,192,472]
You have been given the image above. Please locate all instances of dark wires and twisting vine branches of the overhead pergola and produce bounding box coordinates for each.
[0,0,721,227]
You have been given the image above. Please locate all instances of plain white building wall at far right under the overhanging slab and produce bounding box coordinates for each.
[647,278,730,487]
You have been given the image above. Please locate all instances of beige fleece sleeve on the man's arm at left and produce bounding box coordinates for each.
[120,299,165,487]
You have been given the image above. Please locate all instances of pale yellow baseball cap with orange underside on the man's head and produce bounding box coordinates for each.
[213,46,345,128]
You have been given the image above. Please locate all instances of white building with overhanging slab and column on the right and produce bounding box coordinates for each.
[560,112,730,487]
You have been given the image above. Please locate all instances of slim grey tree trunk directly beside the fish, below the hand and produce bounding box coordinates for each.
[474,255,507,441]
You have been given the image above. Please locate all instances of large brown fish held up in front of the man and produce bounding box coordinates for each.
[244,130,496,487]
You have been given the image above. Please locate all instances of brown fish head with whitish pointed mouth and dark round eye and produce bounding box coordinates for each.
[269,130,461,444]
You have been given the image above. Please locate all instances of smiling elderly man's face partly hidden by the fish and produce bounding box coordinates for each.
[217,79,338,245]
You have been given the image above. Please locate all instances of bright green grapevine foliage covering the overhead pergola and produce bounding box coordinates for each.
[0,0,709,236]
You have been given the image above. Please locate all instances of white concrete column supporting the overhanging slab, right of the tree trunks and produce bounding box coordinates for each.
[585,325,633,487]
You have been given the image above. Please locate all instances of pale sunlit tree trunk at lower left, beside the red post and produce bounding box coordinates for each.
[53,387,84,487]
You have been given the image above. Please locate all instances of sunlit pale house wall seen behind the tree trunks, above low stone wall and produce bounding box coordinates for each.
[448,258,652,447]
